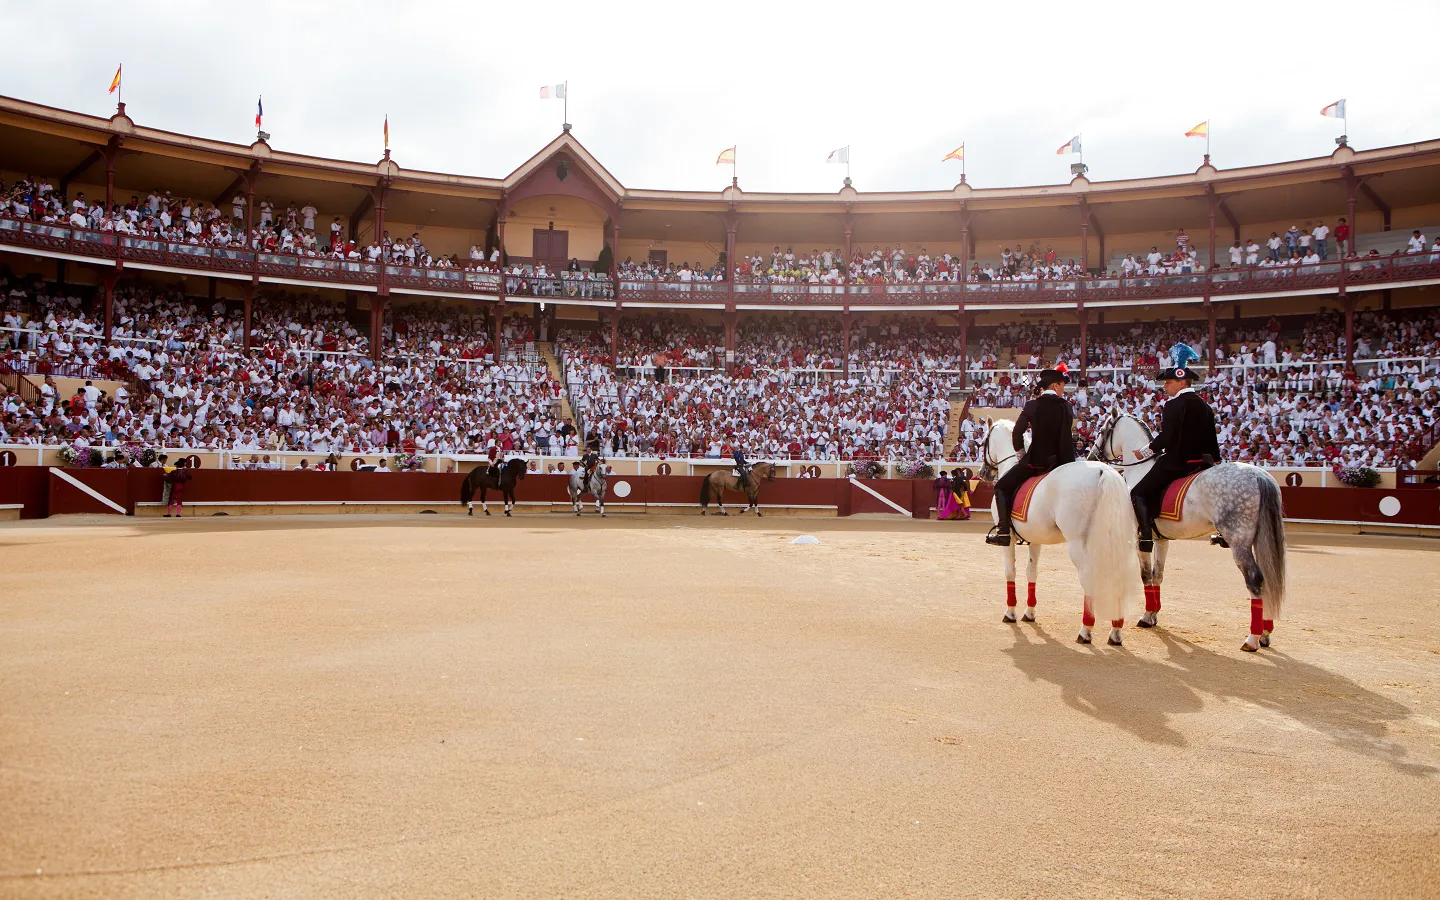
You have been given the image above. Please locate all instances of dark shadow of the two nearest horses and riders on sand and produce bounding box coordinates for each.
[1004,626,1440,778]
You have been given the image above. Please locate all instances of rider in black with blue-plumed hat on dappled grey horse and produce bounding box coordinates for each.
[1130,364,1220,553]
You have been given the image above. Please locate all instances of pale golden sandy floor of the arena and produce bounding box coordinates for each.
[0,516,1440,899]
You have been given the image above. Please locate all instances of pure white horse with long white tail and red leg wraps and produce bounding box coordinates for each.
[981,419,1138,647]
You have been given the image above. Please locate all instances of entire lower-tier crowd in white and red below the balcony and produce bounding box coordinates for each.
[0,259,1440,465]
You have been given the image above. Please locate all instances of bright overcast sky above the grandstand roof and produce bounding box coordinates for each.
[0,0,1440,192]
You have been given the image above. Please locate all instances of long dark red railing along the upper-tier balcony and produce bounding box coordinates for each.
[0,217,1440,307]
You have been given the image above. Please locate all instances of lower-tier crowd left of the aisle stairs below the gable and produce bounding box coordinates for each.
[0,273,561,454]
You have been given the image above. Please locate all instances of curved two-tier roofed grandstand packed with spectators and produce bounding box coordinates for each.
[0,92,1440,472]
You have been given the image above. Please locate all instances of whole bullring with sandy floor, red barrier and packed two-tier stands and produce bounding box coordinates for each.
[0,52,1440,899]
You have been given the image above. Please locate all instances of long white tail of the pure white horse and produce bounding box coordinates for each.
[1080,465,1140,622]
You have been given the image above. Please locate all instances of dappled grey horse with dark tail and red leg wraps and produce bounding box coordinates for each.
[1090,410,1286,652]
